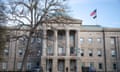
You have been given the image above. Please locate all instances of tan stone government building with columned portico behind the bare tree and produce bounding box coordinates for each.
[0,20,120,72]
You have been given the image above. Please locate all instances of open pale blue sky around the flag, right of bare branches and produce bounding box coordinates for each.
[68,0,120,27]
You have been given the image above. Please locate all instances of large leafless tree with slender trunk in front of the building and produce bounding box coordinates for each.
[7,0,67,71]
